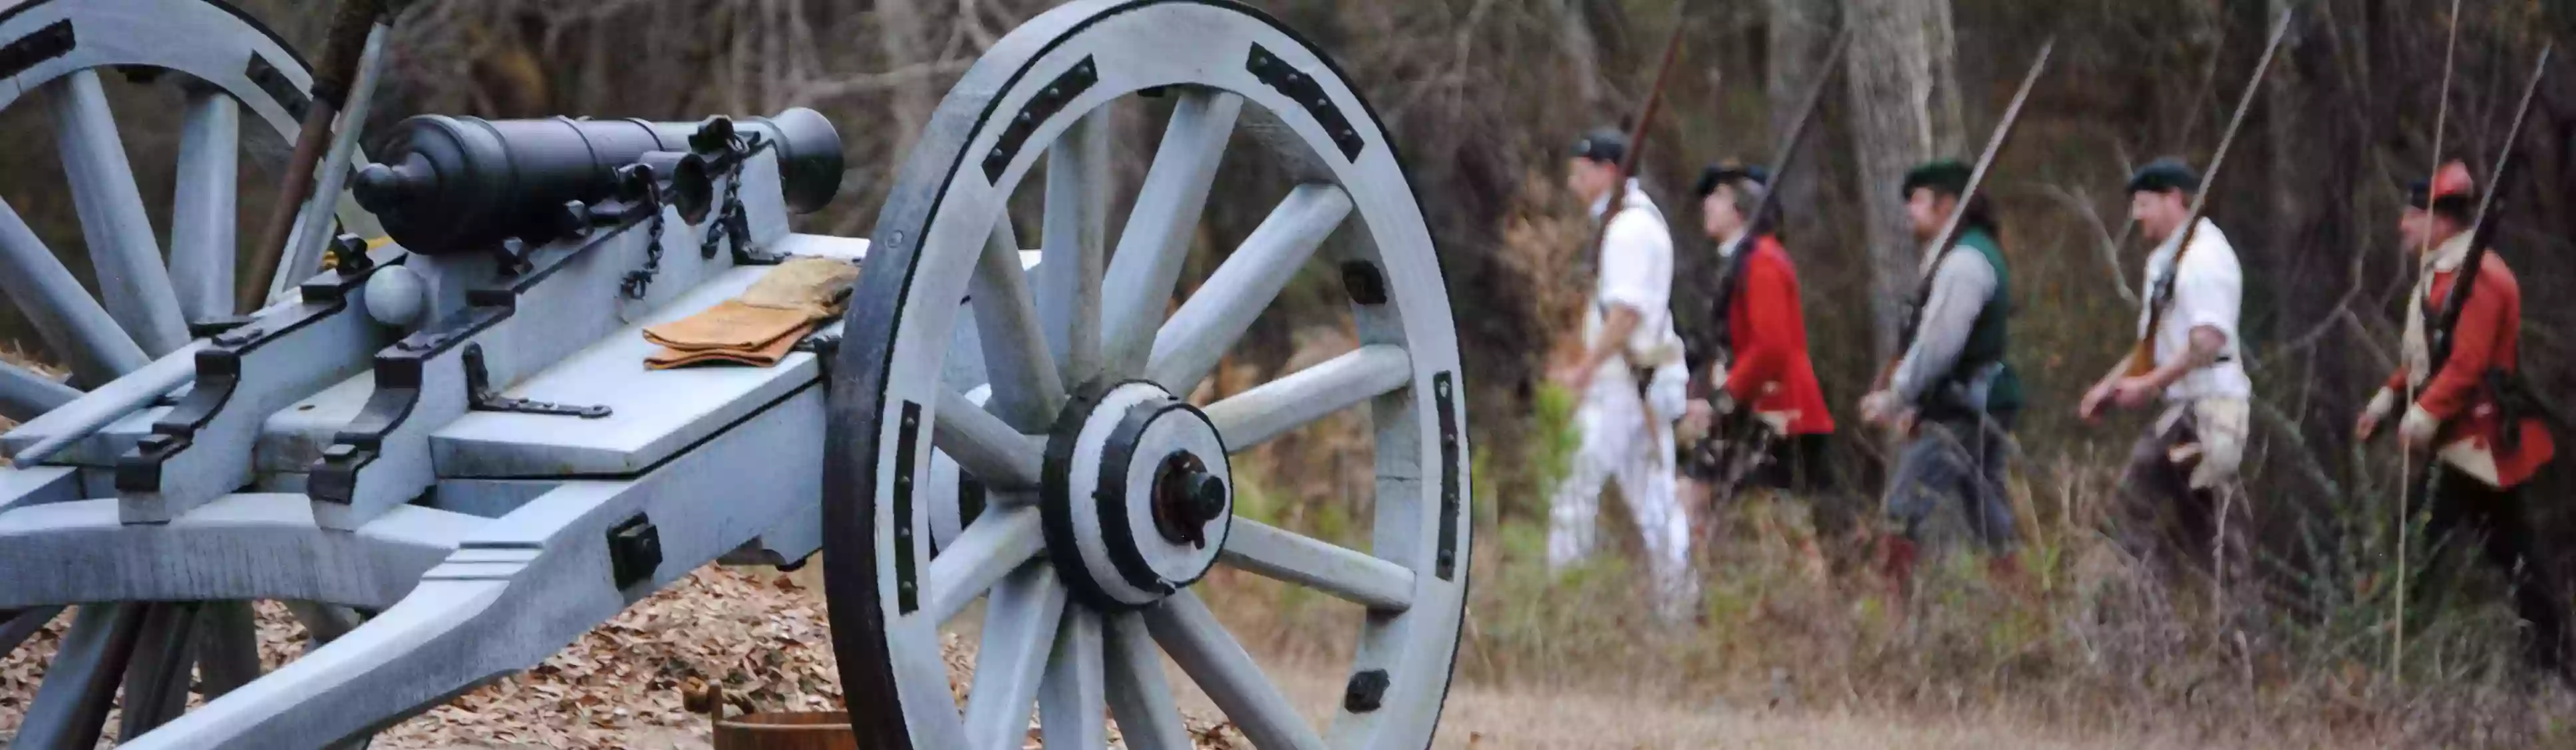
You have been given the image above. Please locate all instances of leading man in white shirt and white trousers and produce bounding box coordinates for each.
[1548,129,1698,621]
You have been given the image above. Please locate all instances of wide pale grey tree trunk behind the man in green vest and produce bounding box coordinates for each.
[1844,0,1947,358]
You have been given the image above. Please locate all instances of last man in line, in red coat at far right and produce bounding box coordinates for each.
[2354,162,2568,678]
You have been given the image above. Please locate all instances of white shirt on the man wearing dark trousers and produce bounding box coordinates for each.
[2138,219,2254,402]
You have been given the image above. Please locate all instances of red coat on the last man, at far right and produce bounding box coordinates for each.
[2388,242,2558,487]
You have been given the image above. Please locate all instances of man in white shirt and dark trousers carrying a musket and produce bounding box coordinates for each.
[2076,157,2254,574]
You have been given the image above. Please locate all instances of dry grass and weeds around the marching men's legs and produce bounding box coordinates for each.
[1223,384,2576,747]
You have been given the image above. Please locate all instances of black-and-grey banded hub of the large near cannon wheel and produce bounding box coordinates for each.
[1038,382,1234,608]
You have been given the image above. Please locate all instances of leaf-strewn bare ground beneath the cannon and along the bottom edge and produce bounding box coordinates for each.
[0,570,2205,750]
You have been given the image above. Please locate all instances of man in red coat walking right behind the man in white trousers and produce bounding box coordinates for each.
[1682,162,1834,511]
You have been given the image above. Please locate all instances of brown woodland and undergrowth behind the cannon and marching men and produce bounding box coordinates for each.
[0,0,2576,745]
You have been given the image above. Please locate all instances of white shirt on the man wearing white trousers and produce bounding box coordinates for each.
[1584,178,1672,382]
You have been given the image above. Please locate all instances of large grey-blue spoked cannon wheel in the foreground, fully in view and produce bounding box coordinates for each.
[824,0,1471,750]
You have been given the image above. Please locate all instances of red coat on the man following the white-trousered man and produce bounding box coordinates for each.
[1726,237,1834,436]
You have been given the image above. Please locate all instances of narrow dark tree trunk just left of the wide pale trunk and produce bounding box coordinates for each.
[1764,0,1834,237]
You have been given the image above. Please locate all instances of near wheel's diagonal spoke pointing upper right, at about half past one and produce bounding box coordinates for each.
[1146,183,1350,394]
